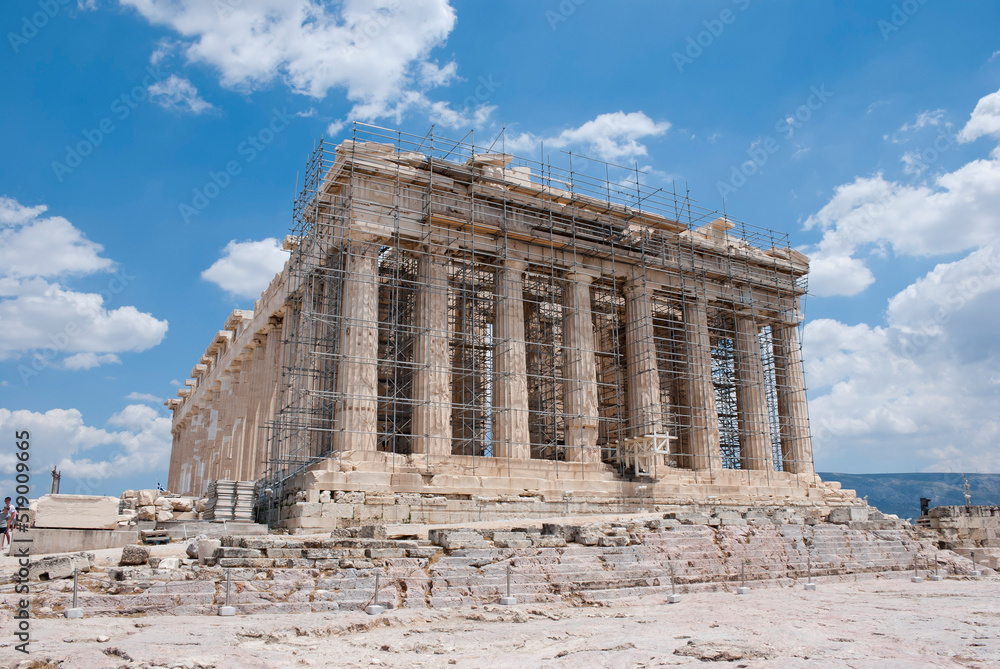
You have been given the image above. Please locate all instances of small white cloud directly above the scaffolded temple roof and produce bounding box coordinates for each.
[507,111,670,162]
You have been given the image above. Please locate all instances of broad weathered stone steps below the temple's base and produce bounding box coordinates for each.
[0,518,984,616]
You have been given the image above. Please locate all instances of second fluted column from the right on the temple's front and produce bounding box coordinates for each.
[734,314,774,470]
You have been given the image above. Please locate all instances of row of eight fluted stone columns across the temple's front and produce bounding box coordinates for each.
[334,242,812,473]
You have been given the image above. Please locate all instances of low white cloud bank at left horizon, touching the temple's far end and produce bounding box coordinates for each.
[0,404,171,494]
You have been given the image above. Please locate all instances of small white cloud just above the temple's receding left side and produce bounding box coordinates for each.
[201,237,288,298]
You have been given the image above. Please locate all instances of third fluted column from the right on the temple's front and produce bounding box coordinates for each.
[684,296,722,470]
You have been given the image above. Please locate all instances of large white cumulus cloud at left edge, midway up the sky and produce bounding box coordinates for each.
[0,197,167,370]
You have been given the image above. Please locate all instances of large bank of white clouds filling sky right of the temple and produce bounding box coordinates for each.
[803,87,1000,472]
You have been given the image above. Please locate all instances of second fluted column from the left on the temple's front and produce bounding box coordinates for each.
[413,246,451,456]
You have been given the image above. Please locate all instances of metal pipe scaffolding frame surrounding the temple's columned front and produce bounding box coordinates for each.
[254,123,806,520]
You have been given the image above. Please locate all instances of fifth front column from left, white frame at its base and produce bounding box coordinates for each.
[625,277,663,437]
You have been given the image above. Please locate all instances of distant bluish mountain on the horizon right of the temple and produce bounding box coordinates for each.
[817,472,1000,520]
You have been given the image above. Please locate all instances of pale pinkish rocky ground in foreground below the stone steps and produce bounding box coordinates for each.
[0,574,1000,669]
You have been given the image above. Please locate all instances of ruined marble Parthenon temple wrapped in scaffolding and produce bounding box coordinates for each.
[167,124,838,528]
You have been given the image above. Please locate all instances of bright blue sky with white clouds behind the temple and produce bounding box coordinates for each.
[0,0,1000,494]
